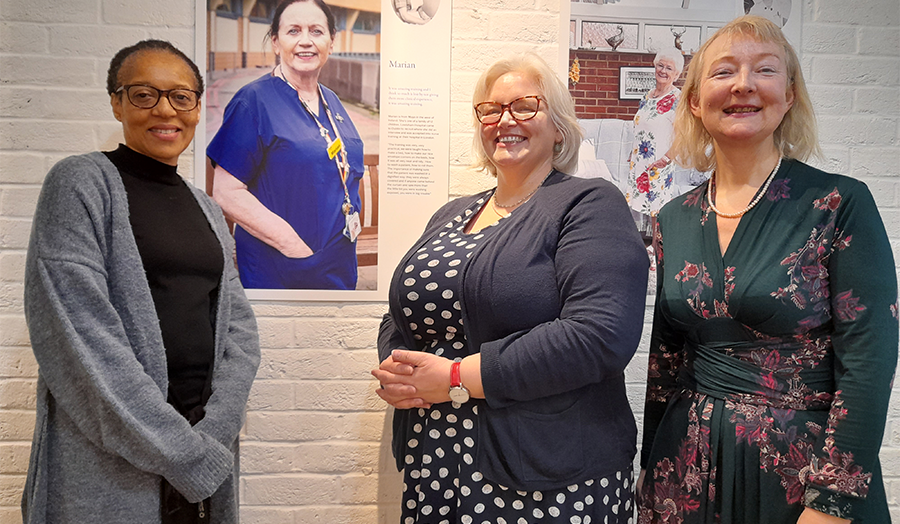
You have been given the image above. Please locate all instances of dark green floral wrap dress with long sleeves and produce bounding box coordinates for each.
[638,160,898,524]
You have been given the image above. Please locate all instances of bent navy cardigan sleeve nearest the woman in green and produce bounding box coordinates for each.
[482,184,649,408]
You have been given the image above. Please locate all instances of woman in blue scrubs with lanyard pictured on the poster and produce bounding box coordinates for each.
[206,0,363,289]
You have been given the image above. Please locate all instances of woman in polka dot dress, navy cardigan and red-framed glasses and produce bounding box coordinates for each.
[372,54,649,523]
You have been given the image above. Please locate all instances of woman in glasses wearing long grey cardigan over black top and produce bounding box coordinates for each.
[22,40,259,524]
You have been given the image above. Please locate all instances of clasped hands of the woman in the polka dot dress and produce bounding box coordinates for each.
[372,349,453,409]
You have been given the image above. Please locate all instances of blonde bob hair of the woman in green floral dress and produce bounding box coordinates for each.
[672,15,821,171]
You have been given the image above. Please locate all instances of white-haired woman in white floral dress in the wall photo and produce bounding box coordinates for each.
[624,47,684,239]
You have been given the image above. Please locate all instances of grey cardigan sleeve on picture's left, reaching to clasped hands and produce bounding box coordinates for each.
[25,157,234,501]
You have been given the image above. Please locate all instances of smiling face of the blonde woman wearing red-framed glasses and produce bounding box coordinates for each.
[481,72,563,180]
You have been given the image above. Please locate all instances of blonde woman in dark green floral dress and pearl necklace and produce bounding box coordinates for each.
[638,16,898,524]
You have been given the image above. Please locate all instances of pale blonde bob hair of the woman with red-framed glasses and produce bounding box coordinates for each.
[472,52,583,176]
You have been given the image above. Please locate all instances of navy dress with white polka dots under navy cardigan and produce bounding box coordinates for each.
[400,198,634,524]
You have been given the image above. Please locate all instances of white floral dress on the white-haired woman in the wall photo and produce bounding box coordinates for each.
[624,87,681,216]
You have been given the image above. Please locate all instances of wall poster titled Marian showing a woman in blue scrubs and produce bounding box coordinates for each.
[195,0,452,302]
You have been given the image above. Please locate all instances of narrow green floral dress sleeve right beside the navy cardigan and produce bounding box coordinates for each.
[641,219,684,468]
